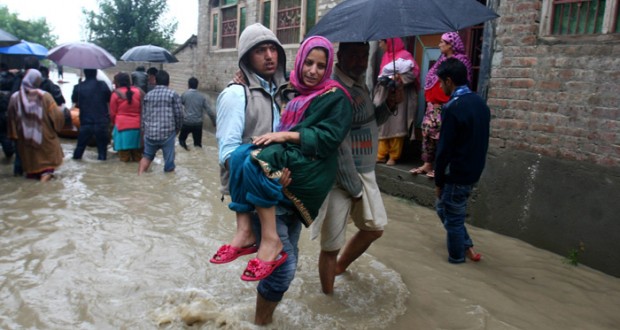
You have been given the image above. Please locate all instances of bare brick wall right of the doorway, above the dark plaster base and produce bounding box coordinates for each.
[488,0,620,167]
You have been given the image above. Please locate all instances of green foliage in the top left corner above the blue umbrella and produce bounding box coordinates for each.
[0,5,58,49]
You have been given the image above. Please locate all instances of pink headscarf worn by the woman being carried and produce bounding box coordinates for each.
[278,36,351,132]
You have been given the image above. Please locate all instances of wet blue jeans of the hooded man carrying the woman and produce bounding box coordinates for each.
[252,213,301,302]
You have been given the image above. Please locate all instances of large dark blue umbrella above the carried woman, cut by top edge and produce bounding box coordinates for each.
[308,0,498,42]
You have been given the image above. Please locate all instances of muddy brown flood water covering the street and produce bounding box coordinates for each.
[0,71,620,330]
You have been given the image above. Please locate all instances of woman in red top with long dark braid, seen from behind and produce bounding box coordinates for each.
[110,72,142,162]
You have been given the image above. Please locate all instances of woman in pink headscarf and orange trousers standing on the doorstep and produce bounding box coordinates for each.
[374,38,420,166]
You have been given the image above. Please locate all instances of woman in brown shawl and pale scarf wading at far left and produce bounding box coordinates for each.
[8,69,68,182]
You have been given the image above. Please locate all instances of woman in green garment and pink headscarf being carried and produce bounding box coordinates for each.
[211,36,353,281]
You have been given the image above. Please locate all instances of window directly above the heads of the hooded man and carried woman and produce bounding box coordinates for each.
[260,0,316,44]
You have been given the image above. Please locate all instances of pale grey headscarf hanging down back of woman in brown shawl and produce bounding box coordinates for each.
[17,69,45,146]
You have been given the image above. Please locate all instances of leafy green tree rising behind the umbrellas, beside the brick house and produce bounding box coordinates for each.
[82,0,178,58]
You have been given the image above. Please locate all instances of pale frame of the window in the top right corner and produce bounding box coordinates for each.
[539,0,620,38]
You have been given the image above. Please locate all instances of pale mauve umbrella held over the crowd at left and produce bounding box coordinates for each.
[47,42,116,69]
